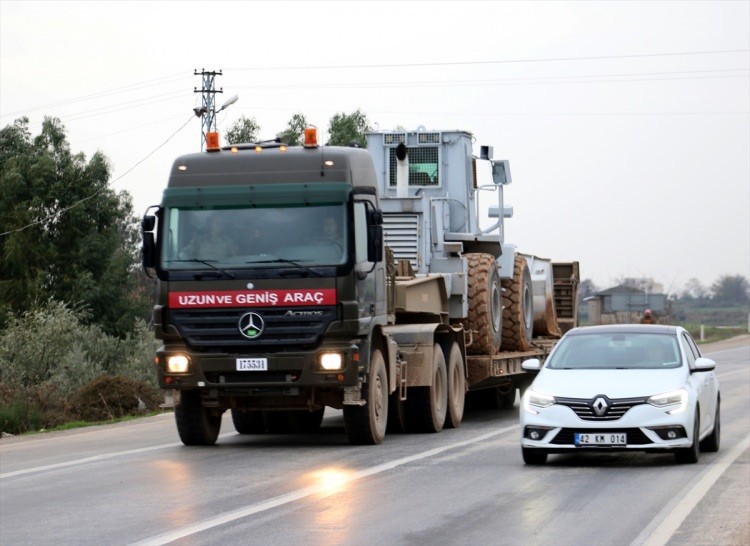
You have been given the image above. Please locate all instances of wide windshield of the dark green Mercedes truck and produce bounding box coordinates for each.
[161,204,348,270]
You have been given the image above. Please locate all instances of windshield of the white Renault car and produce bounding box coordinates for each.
[546,333,681,370]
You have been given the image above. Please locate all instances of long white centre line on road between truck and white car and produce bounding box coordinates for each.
[133,425,518,546]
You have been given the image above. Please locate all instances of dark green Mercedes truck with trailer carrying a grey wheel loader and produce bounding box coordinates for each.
[142,128,579,445]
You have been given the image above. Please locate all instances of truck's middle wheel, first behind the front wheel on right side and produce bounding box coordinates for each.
[406,344,448,432]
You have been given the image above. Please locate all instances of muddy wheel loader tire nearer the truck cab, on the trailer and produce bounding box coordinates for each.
[464,253,503,355]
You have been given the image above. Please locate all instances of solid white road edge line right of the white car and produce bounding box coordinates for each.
[631,434,750,546]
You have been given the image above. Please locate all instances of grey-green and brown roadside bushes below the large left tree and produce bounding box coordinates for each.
[0,300,159,434]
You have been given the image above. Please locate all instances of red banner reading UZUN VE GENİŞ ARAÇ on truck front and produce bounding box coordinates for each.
[169,288,336,309]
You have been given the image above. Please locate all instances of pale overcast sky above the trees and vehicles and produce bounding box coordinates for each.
[0,0,750,293]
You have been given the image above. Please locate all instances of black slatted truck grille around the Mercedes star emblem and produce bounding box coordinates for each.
[169,306,337,350]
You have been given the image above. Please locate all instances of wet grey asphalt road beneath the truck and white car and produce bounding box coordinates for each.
[0,337,750,546]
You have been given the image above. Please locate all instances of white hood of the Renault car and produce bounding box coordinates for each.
[531,368,687,398]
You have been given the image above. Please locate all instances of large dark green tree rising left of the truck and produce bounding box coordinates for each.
[0,118,150,336]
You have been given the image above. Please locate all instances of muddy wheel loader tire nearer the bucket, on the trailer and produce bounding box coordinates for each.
[502,256,534,351]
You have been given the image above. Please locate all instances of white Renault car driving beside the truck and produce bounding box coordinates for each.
[521,324,721,464]
